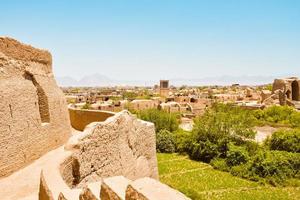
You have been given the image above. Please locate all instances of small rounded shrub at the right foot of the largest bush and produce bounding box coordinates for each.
[226,143,249,167]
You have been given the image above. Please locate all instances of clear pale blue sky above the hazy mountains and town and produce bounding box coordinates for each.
[0,0,300,80]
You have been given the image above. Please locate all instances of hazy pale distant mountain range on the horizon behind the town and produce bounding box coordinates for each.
[56,74,286,87]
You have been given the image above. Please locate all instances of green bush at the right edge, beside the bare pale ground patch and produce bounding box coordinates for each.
[265,129,300,153]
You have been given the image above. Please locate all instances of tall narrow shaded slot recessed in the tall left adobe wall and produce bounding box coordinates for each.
[24,72,50,123]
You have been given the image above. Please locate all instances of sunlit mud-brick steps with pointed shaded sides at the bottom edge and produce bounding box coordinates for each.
[39,175,190,200]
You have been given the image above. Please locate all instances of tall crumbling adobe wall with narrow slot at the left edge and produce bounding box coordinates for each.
[0,37,71,177]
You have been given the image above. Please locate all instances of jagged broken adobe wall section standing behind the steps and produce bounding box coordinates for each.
[62,110,158,186]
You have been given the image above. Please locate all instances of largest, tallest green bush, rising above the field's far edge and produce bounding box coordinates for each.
[187,104,255,162]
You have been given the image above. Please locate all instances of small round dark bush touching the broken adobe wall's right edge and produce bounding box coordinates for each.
[156,130,175,153]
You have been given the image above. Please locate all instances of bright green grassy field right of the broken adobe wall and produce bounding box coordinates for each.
[157,154,300,200]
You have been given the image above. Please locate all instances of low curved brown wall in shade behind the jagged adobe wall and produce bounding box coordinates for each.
[68,106,115,131]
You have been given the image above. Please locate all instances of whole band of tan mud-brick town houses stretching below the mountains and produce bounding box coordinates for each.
[63,79,298,118]
